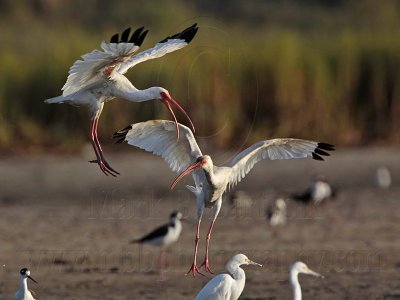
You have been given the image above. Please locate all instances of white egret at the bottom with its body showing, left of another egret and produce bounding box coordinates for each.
[196,254,262,300]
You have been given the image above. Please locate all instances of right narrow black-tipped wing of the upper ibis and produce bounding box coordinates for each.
[118,24,199,74]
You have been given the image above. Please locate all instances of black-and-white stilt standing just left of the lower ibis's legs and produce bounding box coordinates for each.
[131,211,182,279]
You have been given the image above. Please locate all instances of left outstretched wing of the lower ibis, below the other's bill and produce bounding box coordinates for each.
[113,120,202,185]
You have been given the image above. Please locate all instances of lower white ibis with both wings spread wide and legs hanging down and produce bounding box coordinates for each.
[114,120,334,275]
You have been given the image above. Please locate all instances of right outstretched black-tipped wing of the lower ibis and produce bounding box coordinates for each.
[227,138,335,187]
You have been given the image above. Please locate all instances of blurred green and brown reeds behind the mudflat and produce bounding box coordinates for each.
[0,0,400,153]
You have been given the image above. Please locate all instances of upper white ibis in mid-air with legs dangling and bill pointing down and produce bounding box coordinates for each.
[45,24,198,176]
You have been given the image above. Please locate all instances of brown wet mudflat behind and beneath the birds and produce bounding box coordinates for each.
[0,149,400,299]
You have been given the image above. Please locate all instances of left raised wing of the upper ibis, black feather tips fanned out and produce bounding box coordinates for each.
[62,27,147,96]
